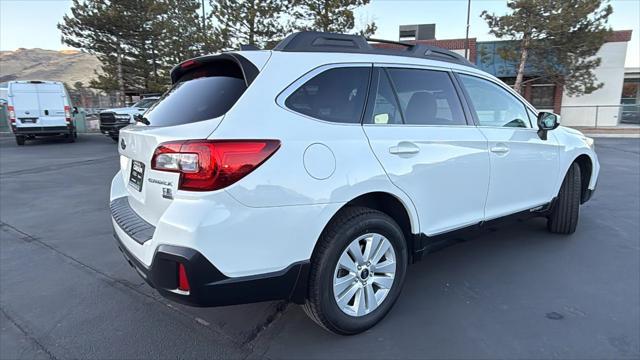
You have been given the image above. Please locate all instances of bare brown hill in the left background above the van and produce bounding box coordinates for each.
[0,49,100,85]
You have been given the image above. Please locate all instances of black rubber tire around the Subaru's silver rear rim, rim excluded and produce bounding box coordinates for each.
[303,207,408,335]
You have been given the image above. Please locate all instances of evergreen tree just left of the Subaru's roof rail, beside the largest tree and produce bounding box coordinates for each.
[210,0,289,48]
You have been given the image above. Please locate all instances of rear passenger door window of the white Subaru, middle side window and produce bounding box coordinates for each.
[388,68,467,125]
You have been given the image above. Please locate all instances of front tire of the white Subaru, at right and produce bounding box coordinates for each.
[547,163,582,234]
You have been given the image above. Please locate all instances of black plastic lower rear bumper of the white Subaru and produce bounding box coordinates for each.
[114,232,309,306]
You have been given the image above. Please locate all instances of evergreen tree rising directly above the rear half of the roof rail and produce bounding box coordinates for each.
[291,0,377,36]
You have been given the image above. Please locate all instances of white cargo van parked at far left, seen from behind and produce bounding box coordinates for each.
[7,81,78,145]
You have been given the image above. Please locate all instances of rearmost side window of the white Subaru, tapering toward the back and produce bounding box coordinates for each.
[285,67,371,124]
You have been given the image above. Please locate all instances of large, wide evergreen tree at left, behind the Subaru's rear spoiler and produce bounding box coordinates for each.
[58,0,211,97]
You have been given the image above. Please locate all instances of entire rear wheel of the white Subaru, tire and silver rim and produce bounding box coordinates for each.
[303,207,408,335]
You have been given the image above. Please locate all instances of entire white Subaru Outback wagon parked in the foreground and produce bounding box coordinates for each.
[110,32,600,334]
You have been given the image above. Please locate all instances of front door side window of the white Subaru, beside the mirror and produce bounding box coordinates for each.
[460,74,531,128]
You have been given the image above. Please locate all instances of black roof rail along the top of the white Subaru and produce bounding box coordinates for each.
[273,31,474,66]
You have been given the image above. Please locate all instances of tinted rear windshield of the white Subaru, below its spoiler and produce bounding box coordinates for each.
[144,61,247,126]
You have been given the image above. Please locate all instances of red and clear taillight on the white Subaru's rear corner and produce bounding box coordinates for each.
[151,140,280,191]
